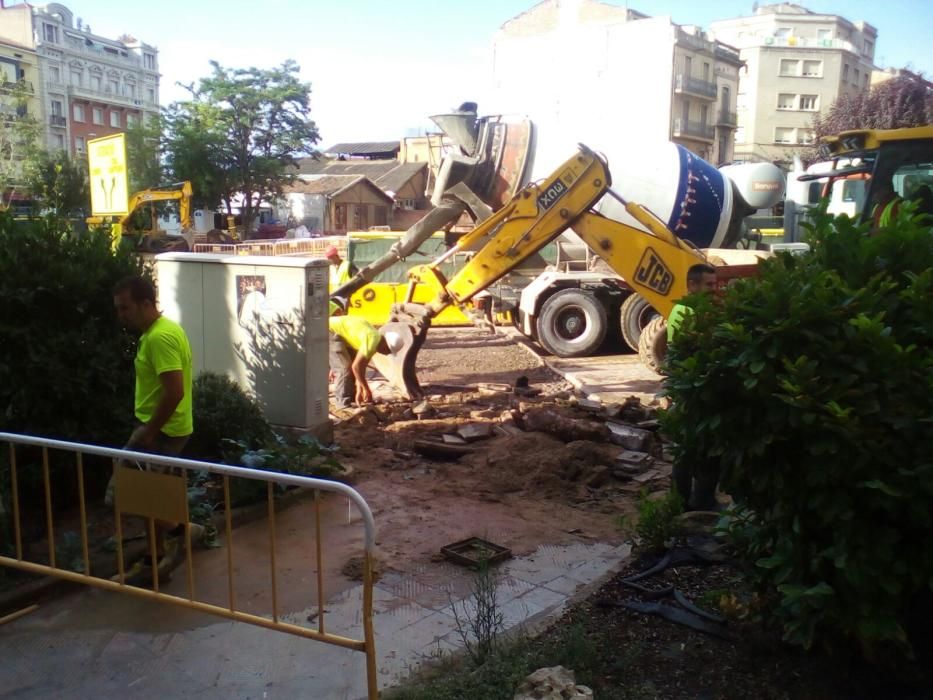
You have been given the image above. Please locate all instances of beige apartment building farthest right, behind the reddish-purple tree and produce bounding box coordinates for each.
[710,3,878,163]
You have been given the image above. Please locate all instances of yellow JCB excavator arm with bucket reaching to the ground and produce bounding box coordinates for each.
[374,144,706,398]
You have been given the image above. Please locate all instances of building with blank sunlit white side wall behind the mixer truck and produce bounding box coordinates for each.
[492,0,741,173]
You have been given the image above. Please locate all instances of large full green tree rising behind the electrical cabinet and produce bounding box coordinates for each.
[166,60,320,231]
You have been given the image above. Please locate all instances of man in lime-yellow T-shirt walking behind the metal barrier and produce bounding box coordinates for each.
[108,277,197,581]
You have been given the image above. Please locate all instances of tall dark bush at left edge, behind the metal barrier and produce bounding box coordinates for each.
[0,212,142,516]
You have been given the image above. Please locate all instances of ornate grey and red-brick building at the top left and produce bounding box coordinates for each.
[0,3,159,157]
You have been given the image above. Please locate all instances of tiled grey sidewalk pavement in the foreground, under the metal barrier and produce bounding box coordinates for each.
[0,544,629,700]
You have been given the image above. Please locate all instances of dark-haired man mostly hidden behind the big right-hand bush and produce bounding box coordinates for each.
[667,263,719,510]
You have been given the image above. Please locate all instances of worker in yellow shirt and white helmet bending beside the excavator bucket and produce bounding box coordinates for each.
[327,302,389,408]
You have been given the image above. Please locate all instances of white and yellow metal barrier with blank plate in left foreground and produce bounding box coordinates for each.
[0,433,378,700]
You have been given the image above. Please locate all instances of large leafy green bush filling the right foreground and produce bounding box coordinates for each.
[663,206,933,658]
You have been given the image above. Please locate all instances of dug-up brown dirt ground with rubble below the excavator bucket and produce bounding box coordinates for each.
[335,329,666,569]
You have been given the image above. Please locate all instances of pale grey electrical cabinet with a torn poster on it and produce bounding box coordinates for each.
[155,253,331,440]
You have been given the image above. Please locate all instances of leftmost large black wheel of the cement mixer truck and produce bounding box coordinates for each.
[537,289,609,357]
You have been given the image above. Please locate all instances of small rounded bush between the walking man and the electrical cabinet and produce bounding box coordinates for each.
[185,372,273,462]
